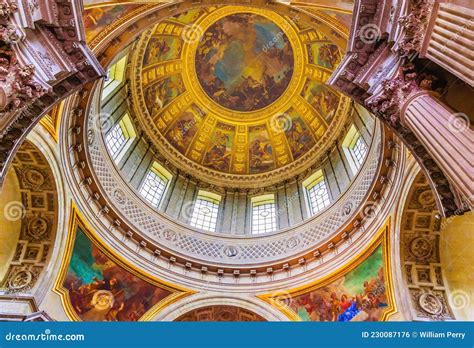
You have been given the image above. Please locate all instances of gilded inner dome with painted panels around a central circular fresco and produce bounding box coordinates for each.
[130,6,350,185]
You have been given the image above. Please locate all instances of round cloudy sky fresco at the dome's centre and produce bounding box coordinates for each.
[195,13,294,112]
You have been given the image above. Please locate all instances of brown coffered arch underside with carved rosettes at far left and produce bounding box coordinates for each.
[0,142,58,293]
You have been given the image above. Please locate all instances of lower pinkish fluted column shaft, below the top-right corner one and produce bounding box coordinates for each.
[400,91,474,206]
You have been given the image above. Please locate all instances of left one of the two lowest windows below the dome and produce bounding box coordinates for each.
[190,190,221,232]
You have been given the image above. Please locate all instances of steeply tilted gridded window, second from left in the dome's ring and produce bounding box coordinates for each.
[105,114,136,162]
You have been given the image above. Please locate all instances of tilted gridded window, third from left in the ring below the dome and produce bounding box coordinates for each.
[140,162,172,208]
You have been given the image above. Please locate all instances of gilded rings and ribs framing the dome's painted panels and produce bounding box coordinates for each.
[127,4,351,188]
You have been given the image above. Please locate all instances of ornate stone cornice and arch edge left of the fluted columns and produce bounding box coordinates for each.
[328,0,459,216]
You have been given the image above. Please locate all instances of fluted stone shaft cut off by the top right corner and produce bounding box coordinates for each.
[420,3,474,86]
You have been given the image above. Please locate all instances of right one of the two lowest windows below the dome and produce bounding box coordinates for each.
[252,194,276,234]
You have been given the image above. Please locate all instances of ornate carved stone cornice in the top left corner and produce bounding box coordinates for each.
[0,0,105,183]
